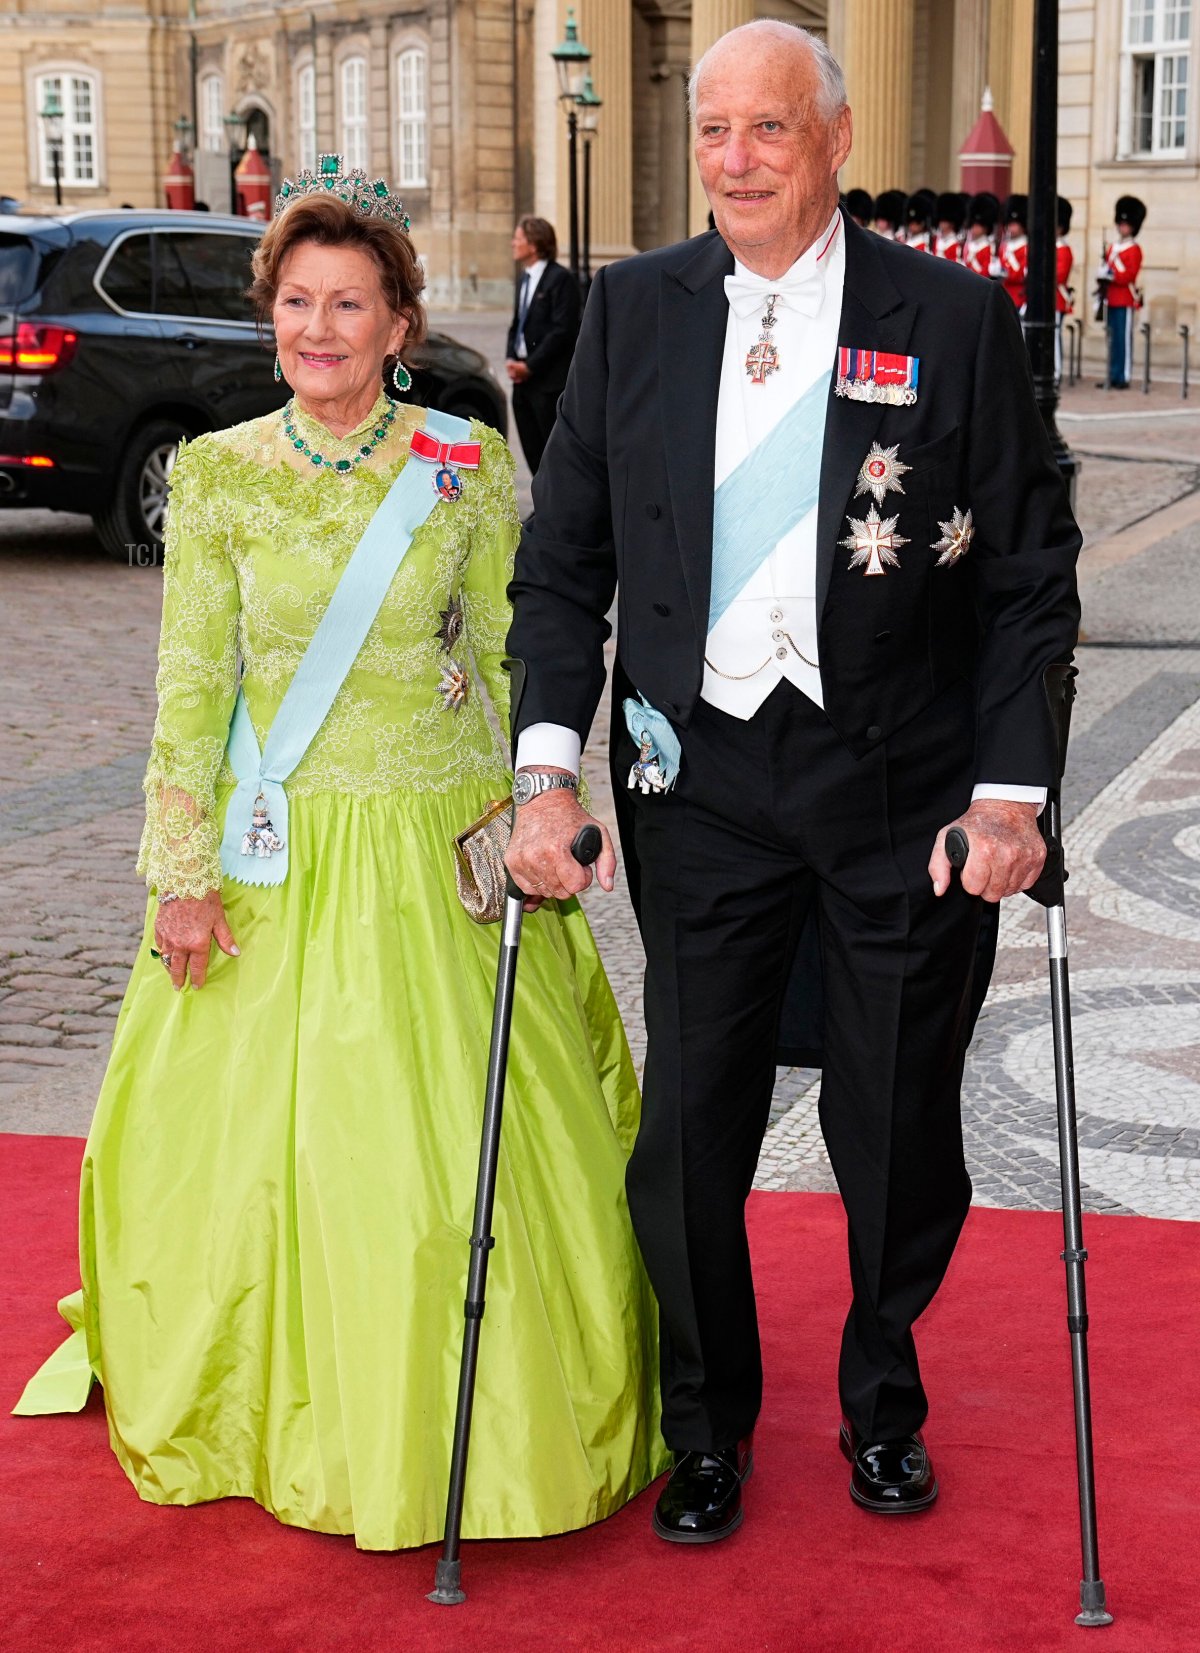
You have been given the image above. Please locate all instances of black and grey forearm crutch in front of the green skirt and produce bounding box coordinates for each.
[428,825,602,1607]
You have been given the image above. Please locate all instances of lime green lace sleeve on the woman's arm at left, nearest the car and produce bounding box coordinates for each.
[137,436,238,896]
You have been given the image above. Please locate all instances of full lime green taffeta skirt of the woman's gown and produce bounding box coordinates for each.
[17,788,666,1549]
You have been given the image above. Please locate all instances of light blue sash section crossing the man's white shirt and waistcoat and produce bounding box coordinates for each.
[709,374,830,631]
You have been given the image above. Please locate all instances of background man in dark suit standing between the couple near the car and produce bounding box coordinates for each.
[504,217,582,474]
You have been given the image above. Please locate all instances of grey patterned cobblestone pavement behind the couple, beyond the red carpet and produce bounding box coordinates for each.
[0,312,1200,1218]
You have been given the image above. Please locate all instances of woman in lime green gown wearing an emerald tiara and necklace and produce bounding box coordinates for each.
[18,164,664,1549]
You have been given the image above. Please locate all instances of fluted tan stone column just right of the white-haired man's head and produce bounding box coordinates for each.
[831,0,919,195]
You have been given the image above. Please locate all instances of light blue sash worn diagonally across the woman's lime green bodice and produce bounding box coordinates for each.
[221,412,471,884]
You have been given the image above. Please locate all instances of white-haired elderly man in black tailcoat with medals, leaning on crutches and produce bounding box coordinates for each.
[507,21,1079,1542]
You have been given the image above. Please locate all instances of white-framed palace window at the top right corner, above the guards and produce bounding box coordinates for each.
[1119,0,1192,155]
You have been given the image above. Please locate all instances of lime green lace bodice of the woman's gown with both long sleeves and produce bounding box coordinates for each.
[137,397,517,896]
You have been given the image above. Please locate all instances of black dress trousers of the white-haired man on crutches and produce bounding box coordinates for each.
[613,681,980,1451]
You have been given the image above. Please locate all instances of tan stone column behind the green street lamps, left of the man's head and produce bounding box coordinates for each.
[575,0,635,257]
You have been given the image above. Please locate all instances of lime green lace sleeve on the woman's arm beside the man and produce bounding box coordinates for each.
[463,423,521,742]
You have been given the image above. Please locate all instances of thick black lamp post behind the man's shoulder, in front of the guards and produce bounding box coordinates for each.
[1021,0,1079,504]
